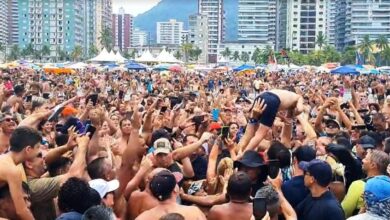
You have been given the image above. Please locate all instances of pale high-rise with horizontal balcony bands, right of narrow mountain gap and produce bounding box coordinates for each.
[238,0,277,45]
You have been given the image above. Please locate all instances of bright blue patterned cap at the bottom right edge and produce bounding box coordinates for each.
[364,175,390,219]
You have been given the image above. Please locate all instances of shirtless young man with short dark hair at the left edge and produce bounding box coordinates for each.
[0,127,42,220]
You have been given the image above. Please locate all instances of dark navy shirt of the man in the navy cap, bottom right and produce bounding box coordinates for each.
[296,191,345,220]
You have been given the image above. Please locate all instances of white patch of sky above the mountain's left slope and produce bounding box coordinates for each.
[112,0,161,16]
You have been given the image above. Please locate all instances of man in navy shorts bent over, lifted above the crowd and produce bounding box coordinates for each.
[245,89,304,150]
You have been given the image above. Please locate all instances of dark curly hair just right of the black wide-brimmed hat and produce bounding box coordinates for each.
[267,141,291,168]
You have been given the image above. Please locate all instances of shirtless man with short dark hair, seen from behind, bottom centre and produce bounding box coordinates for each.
[208,172,253,220]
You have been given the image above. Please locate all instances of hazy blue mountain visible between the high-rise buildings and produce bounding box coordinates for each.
[134,0,238,43]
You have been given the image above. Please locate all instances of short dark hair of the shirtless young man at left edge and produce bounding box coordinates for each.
[9,126,42,152]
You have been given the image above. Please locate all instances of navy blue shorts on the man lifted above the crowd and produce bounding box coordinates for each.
[252,92,280,127]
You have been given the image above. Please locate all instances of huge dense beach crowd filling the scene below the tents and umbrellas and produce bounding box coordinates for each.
[0,68,390,220]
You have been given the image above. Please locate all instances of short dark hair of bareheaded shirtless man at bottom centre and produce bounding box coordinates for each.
[227,172,252,200]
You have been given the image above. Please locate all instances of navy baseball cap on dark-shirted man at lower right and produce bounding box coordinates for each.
[299,159,332,187]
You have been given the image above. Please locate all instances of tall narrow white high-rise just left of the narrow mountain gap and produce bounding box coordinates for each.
[198,0,225,63]
